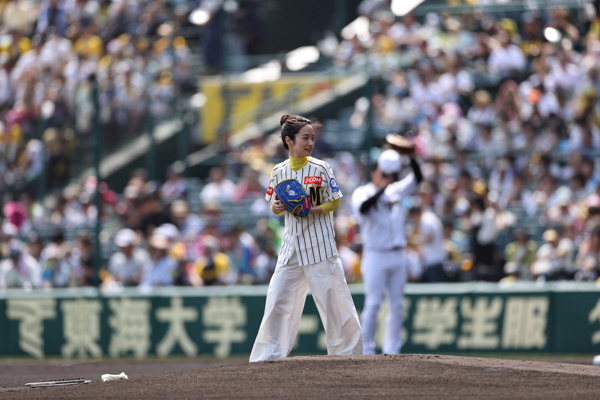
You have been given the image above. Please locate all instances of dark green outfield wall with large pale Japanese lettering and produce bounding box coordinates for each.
[0,282,600,358]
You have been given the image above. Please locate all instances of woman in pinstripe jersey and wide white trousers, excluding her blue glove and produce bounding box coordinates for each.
[250,114,363,362]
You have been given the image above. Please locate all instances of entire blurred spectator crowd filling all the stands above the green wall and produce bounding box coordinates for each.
[0,0,600,289]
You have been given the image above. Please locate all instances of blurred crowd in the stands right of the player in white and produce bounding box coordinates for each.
[325,0,600,282]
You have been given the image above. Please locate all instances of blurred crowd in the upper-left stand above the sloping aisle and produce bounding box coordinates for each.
[0,0,191,191]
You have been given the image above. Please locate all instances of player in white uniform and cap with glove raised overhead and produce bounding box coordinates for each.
[352,150,423,354]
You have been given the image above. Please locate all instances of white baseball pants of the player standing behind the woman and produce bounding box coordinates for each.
[360,250,407,354]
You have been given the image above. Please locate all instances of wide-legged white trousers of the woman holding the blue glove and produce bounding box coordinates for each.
[250,253,363,362]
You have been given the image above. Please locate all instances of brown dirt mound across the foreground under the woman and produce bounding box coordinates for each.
[0,354,600,399]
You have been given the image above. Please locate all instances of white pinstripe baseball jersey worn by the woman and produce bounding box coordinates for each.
[265,157,342,265]
